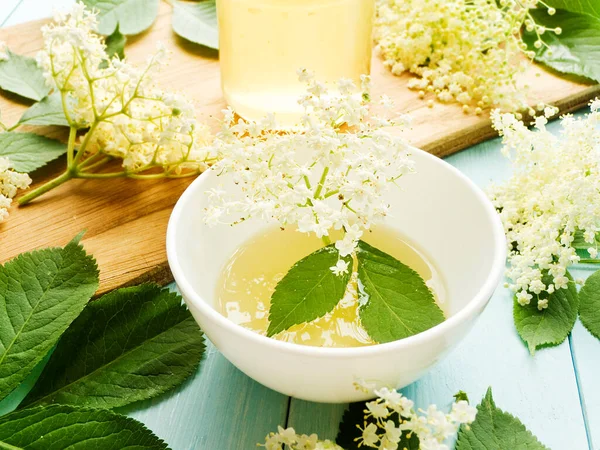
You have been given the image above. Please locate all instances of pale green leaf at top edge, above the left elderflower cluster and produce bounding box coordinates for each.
[82,0,159,36]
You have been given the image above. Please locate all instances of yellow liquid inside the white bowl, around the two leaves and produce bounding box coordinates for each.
[217,226,446,347]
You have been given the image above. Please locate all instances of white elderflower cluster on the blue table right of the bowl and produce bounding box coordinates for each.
[490,100,600,310]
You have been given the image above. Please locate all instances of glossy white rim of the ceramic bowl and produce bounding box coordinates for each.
[166,147,506,358]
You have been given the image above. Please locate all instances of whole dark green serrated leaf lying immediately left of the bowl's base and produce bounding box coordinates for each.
[22,284,205,409]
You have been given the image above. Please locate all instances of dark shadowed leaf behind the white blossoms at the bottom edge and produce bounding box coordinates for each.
[335,402,419,450]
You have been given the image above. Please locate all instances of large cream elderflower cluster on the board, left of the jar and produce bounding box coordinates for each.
[37,3,209,176]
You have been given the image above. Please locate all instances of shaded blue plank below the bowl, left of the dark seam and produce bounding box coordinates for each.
[120,343,288,450]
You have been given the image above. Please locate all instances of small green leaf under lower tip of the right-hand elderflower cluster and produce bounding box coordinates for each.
[513,272,579,355]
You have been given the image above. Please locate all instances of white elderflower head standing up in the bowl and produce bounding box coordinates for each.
[205,70,414,262]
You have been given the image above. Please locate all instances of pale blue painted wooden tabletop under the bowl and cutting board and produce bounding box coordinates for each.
[0,0,600,450]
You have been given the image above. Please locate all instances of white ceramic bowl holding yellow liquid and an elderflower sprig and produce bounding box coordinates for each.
[167,149,505,402]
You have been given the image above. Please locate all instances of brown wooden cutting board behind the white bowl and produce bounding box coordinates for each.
[0,3,600,294]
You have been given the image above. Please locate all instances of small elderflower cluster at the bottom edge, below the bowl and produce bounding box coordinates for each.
[263,383,477,450]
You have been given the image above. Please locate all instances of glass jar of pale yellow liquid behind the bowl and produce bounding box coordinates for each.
[217,0,375,128]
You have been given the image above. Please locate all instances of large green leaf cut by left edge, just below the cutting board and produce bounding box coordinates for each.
[0,236,98,400]
